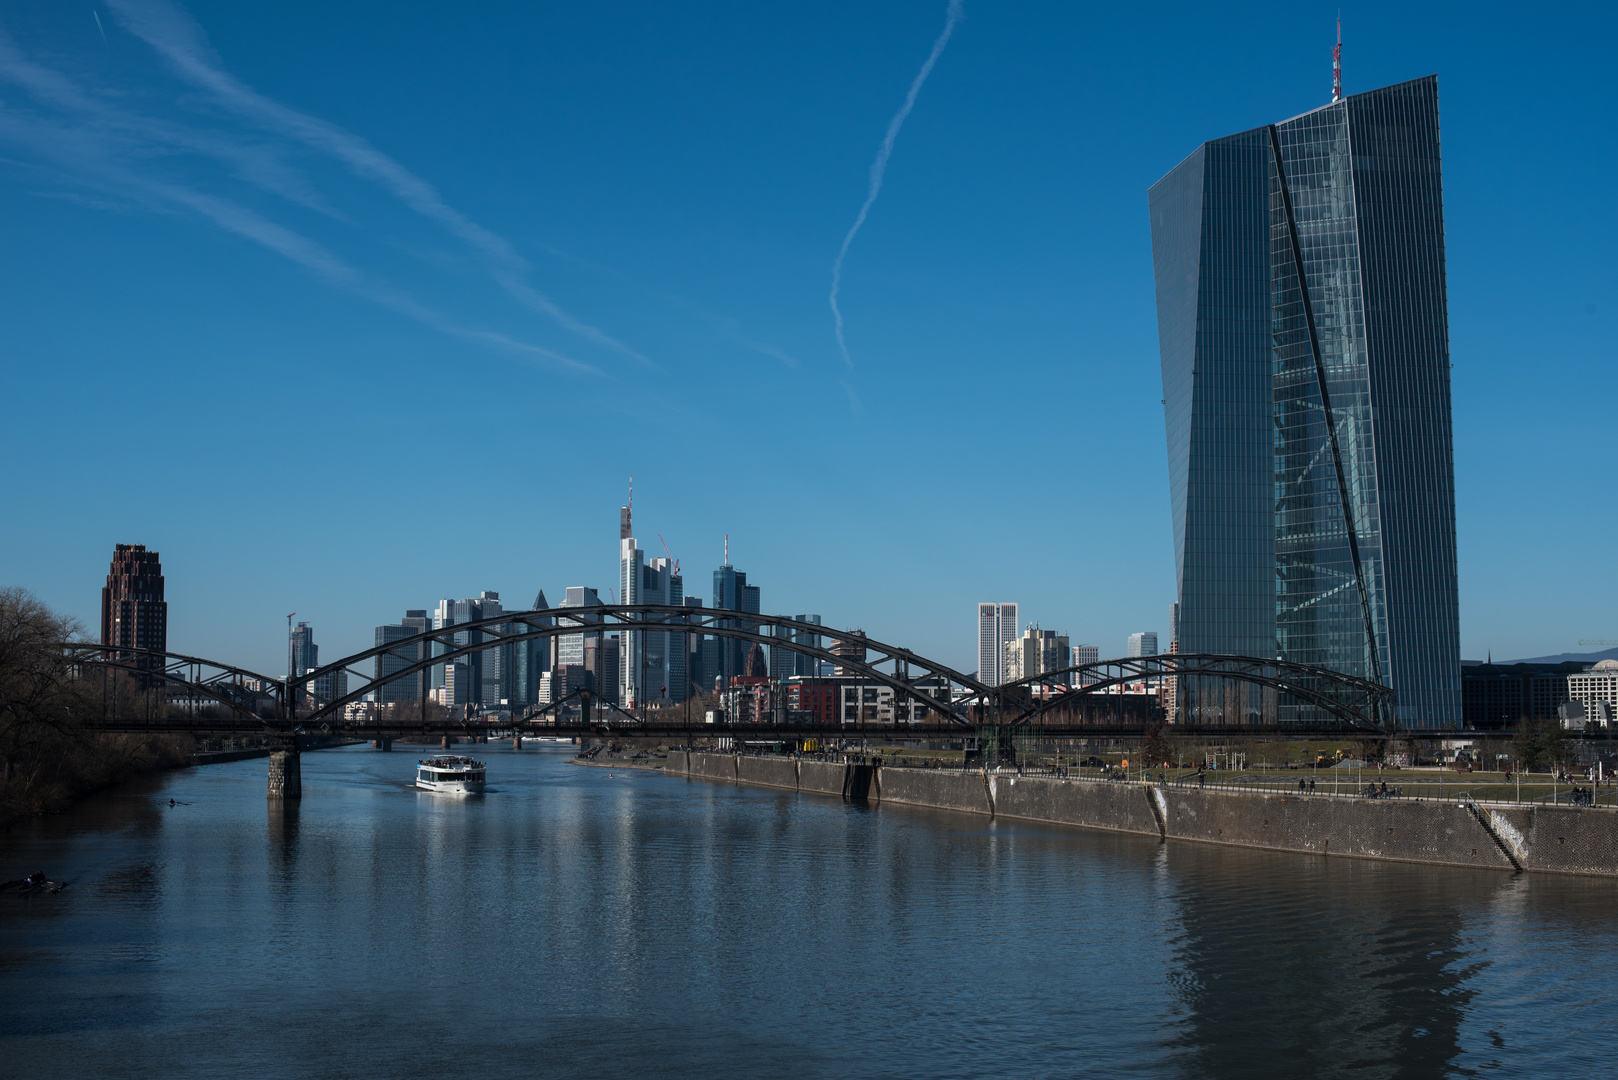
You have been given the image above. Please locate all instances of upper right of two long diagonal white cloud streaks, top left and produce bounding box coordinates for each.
[108,0,655,368]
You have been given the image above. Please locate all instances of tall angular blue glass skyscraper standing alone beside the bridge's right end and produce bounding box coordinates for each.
[1150,76,1461,729]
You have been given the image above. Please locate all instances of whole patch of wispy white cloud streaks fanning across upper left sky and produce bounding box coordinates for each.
[0,0,627,374]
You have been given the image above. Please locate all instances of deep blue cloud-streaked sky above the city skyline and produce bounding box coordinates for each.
[0,0,1618,670]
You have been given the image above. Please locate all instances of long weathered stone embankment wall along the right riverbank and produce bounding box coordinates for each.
[665,751,1618,878]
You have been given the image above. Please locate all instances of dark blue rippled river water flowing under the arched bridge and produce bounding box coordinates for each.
[0,748,1618,1080]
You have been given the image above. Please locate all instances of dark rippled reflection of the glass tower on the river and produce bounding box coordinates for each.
[1167,844,1612,1077]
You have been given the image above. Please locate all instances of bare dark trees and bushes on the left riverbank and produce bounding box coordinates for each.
[0,588,191,823]
